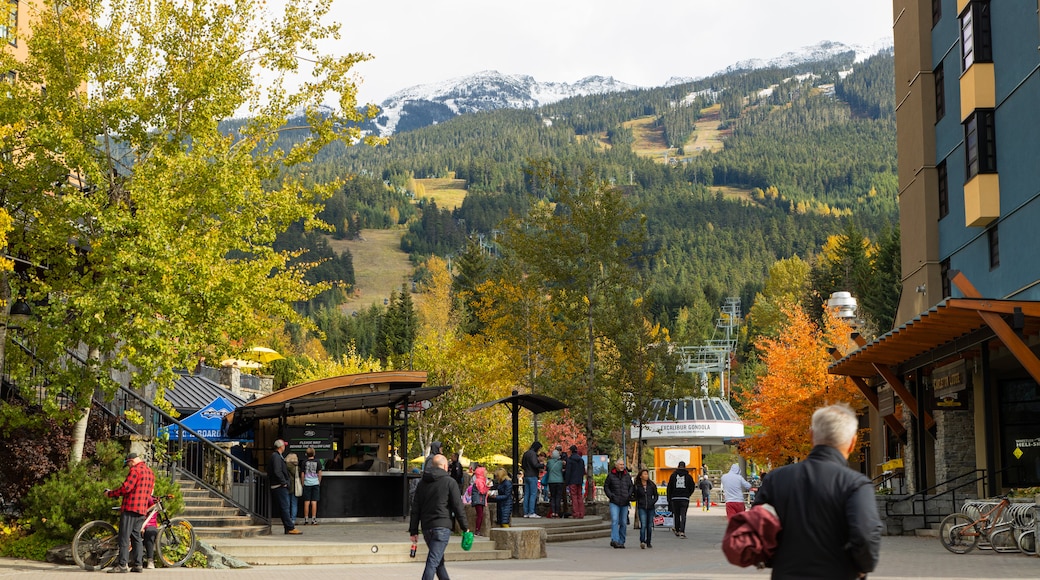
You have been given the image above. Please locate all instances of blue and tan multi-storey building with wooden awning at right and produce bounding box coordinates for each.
[831,0,1040,503]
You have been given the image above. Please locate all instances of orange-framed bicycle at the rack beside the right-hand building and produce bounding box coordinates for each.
[939,495,1036,554]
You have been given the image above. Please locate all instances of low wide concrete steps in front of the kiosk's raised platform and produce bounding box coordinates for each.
[204,532,512,565]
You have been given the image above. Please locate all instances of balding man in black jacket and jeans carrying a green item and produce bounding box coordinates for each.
[408,454,469,580]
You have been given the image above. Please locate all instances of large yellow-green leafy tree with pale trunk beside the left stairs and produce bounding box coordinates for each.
[0,0,382,460]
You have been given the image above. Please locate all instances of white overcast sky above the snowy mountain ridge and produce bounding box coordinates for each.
[332,0,892,103]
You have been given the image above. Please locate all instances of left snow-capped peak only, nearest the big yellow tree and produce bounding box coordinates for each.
[375,71,639,135]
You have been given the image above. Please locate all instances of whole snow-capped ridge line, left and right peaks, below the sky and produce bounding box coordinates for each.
[366,37,892,136]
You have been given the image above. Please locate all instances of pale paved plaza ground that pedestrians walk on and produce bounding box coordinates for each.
[0,507,1040,580]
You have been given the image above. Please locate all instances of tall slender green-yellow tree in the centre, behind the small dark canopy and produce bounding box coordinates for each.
[502,166,646,459]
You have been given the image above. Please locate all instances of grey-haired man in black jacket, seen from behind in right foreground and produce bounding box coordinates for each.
[755,404,881,580]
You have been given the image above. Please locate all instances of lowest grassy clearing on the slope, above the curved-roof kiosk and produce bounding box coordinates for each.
[329,229,416,314]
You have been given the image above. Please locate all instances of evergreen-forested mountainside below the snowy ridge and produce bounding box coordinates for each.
[272,52,898,349]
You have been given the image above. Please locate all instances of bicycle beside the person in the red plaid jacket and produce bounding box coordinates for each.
[72,495,198,571]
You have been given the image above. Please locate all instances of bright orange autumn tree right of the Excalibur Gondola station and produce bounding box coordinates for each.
[738,304,862,466]
